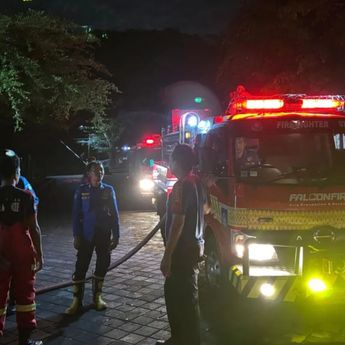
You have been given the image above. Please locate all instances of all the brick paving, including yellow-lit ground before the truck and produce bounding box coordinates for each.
[0,212,345,345]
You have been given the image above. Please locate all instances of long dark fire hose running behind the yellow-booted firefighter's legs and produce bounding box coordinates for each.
[36,215,166,295]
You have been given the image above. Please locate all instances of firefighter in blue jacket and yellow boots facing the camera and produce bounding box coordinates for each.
[65,161,120,315]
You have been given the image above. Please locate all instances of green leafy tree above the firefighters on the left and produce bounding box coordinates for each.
[0,11,116,131]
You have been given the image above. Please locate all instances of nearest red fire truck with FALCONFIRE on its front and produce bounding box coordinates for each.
[158,90,345,302]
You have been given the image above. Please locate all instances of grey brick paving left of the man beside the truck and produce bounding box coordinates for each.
[0,212,169,345]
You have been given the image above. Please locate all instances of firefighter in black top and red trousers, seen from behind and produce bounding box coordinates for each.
[0,151,43,345]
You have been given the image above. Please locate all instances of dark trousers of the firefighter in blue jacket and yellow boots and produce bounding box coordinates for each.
[73,229,111,281]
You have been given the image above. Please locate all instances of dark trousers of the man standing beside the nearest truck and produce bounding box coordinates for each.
[164,254,200,345]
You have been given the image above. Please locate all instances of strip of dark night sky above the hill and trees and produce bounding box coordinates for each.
[0,0,236,34]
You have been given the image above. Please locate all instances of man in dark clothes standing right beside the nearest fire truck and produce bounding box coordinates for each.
[156,145,206,345]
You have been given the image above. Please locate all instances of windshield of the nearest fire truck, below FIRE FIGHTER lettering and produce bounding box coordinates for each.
[234,132,345,184]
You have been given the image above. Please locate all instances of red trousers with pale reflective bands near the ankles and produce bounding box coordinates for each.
[0,227,36,335]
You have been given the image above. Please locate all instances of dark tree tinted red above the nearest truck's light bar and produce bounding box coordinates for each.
[218,0,345,93]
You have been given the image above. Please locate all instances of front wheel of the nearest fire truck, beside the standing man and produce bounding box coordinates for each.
[205,234,226,290]
